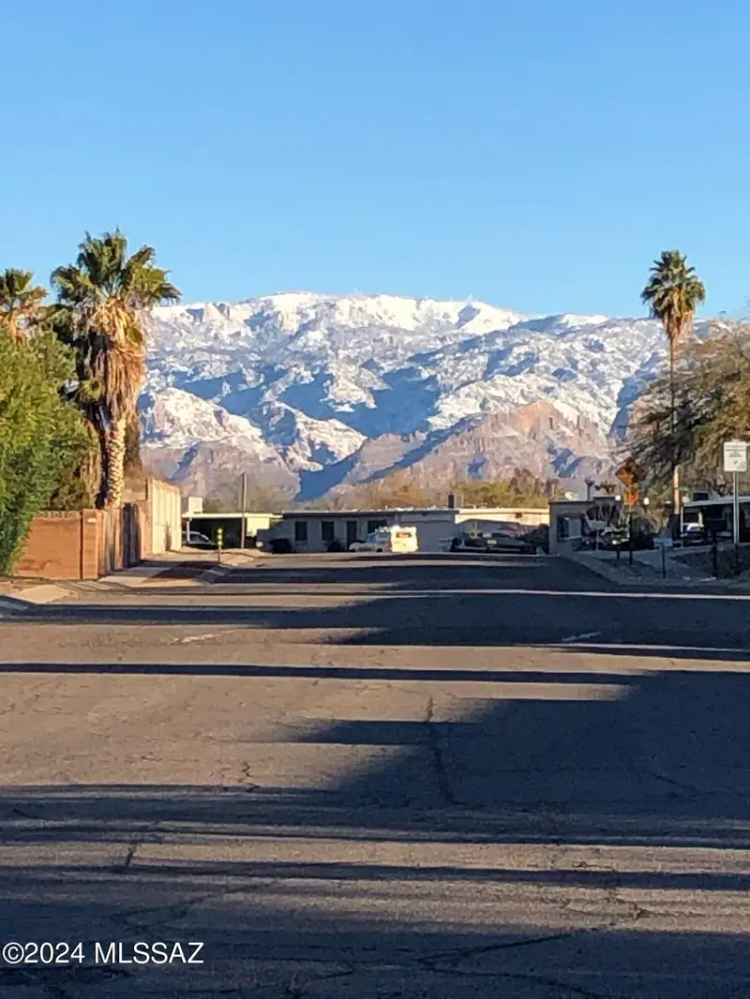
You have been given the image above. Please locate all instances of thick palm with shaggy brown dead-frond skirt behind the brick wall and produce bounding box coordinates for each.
[52,230,180,506]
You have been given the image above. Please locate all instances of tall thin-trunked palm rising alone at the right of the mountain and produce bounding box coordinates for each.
[641,250,706,515]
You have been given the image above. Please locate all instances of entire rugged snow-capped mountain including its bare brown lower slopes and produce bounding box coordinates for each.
[141,293,684,499]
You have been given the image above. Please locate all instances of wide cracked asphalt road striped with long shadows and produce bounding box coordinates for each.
[0,556,750,999]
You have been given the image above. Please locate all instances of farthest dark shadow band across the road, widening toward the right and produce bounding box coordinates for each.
[13,589,750,658]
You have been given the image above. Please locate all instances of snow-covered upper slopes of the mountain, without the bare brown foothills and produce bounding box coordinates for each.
[144,292,676,504]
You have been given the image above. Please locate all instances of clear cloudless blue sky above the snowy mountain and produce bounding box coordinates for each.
[0,0,750,314]
